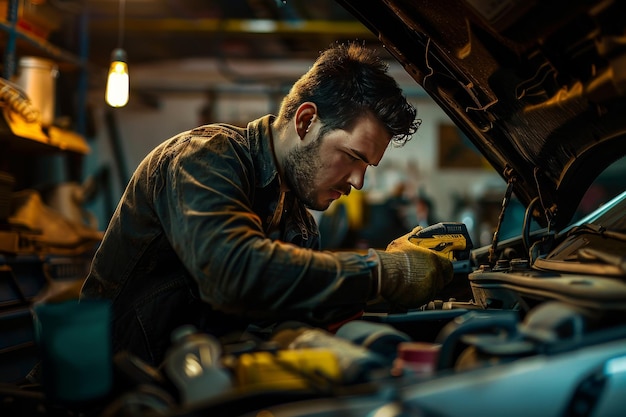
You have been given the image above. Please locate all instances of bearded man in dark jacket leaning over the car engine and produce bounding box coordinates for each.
[81,43,452,365]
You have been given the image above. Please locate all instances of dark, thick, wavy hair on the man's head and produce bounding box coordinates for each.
[275,43,421,146]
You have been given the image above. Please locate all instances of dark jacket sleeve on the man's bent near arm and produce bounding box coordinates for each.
[154,128,375,323]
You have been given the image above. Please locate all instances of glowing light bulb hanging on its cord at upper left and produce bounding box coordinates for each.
[105,0,130,107]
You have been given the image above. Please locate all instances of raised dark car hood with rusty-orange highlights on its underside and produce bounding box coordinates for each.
[337,0,626,230]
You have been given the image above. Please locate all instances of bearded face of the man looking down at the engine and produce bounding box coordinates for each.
[285,115,391,210]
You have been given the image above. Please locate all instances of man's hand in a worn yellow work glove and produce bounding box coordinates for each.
[370,226,453,308]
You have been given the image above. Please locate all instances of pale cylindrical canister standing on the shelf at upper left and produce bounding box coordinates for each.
[15,56,59,126]
